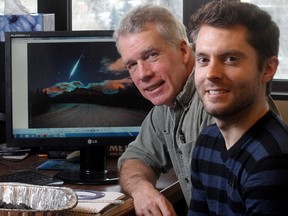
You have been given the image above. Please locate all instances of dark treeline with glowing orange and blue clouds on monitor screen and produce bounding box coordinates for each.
[29,77,152,116]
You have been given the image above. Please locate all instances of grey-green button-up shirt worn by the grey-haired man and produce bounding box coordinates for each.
[118,74,214,204]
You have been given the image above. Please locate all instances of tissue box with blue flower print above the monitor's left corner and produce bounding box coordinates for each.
[0,14,55,41]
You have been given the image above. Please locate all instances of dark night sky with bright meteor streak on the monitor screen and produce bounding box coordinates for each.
[28,42,128,89]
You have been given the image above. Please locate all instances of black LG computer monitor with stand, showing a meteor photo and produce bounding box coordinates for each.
[5,31,152,184]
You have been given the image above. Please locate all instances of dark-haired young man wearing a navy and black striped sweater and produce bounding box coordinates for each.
[189,1,288,216]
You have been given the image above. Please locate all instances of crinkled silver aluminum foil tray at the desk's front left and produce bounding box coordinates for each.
[0,183,78,216]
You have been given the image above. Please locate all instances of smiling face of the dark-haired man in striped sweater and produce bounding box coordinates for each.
[195,25,266,118]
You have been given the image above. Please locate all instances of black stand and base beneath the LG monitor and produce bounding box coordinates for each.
[55,145,119,184]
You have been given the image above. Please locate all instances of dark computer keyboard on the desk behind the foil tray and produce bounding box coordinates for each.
[0,170,64,185]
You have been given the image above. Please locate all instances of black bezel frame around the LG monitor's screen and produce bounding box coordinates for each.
[5,30,143,150]
